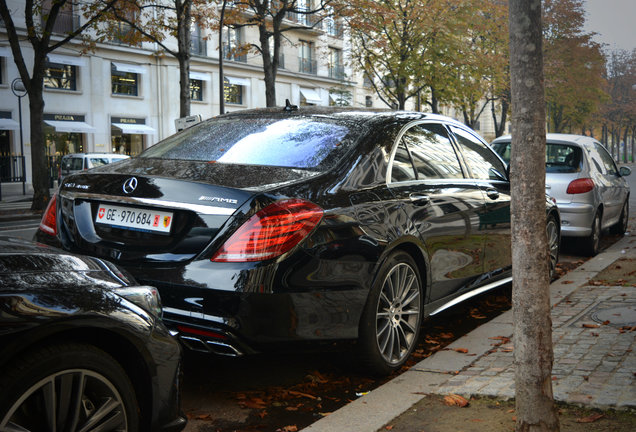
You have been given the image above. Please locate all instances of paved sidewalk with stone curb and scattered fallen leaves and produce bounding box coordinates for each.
[304,228,636,432]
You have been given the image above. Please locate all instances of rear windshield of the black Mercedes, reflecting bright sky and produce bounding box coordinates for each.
[139,118,349,168]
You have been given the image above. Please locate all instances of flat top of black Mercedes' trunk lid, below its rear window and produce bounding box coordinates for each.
[86,158,320,190]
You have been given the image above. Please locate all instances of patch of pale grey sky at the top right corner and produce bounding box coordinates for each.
[585,0,636,51]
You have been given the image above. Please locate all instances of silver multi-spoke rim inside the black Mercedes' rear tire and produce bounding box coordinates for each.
[376,263,420,364]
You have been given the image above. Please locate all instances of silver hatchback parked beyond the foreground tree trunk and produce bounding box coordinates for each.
[491,133,631,255]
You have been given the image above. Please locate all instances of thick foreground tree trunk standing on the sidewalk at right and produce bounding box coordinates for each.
[509,0,559,432]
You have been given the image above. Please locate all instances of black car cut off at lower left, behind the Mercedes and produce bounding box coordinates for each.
[0,237,186,431]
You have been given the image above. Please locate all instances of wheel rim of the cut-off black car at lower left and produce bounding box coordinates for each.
[0,369,128,432]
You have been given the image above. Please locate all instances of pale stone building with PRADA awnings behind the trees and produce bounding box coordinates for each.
[0,0,502,191]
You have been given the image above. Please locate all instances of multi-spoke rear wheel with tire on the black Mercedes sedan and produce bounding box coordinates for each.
[359,251,424,375]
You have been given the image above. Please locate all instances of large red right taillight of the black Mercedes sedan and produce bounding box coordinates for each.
[211,199,323,262]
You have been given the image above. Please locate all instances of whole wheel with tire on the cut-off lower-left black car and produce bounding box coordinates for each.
[0,343,139,432]
